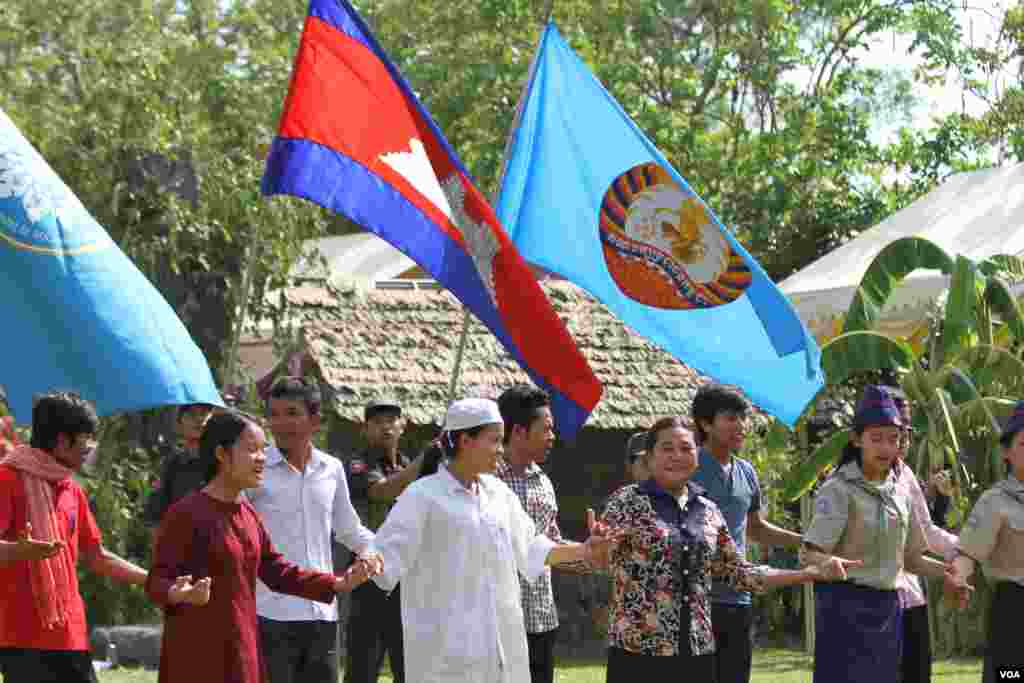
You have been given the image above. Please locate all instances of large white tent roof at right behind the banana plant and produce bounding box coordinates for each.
[779,164,1024,337]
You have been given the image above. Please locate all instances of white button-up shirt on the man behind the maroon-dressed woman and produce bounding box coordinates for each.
[246,447,374,622]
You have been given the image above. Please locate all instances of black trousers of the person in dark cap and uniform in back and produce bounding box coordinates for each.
[346,582,406,683]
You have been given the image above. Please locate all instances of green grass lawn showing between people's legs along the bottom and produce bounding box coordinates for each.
[9,649,981,683]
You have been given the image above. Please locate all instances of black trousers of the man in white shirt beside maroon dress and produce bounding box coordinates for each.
[259,616,338,683]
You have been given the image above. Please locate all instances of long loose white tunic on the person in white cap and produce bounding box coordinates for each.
[374,467,555,683]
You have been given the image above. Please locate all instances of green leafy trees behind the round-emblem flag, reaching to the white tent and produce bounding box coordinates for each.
[365,0,964,279]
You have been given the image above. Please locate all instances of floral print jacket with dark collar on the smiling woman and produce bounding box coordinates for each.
[602,480,766,656]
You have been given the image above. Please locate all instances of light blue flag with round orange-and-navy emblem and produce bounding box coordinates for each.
[498,23,823,426]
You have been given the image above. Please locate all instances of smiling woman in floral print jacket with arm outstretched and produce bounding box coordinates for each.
[603,418,852,683]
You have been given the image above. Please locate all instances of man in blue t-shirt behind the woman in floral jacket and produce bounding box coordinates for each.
[691,384,801,683]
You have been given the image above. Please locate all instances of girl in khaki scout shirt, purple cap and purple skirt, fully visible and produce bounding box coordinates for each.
[801,386,945,683]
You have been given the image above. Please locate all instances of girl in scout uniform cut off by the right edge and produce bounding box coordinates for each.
[946,401,1024,683]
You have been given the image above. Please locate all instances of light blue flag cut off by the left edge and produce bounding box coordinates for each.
[0,110,222,423]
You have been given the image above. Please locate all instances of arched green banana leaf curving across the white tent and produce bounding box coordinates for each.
[843,238,954,333]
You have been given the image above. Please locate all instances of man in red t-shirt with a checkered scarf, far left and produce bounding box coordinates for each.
[0,392,169,683]
